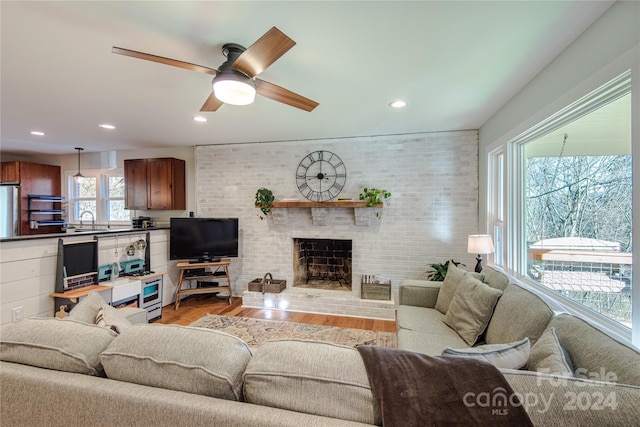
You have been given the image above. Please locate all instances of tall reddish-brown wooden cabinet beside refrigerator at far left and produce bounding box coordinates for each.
[0,161,64,236]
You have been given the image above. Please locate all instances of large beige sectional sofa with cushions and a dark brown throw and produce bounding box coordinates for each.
[0,269,640,427]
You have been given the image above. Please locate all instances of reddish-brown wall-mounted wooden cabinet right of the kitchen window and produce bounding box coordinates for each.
[124,157,187,210]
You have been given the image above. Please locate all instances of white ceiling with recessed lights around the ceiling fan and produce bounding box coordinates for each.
[0,0,612,156]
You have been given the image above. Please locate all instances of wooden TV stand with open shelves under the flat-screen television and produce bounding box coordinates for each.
[175,259,232,310]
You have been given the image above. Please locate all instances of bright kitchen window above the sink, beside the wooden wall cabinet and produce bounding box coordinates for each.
[67,169,131,226]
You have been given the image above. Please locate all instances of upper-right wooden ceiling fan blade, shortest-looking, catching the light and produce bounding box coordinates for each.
[232,27,296,77]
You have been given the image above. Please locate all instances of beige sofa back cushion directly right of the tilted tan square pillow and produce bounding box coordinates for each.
[485,283,553,345]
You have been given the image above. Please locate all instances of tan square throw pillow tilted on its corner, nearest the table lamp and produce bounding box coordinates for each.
[442,276,502,346]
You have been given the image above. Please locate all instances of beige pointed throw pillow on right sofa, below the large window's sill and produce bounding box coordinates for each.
[528,327,574,377]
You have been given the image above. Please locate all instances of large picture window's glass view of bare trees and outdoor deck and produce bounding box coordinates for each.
[525,96,633,327]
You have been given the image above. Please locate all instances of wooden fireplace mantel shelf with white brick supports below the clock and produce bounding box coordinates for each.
[256,200,383,225]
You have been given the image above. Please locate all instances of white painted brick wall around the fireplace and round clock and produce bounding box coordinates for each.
[195,131,478,301]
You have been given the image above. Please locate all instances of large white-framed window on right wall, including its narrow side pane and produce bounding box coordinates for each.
[489,73,633,336]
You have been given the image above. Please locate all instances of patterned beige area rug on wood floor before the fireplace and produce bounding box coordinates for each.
[189,314,397,348]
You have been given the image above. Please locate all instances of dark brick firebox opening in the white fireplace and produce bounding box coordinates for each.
[293,238,352,291]
